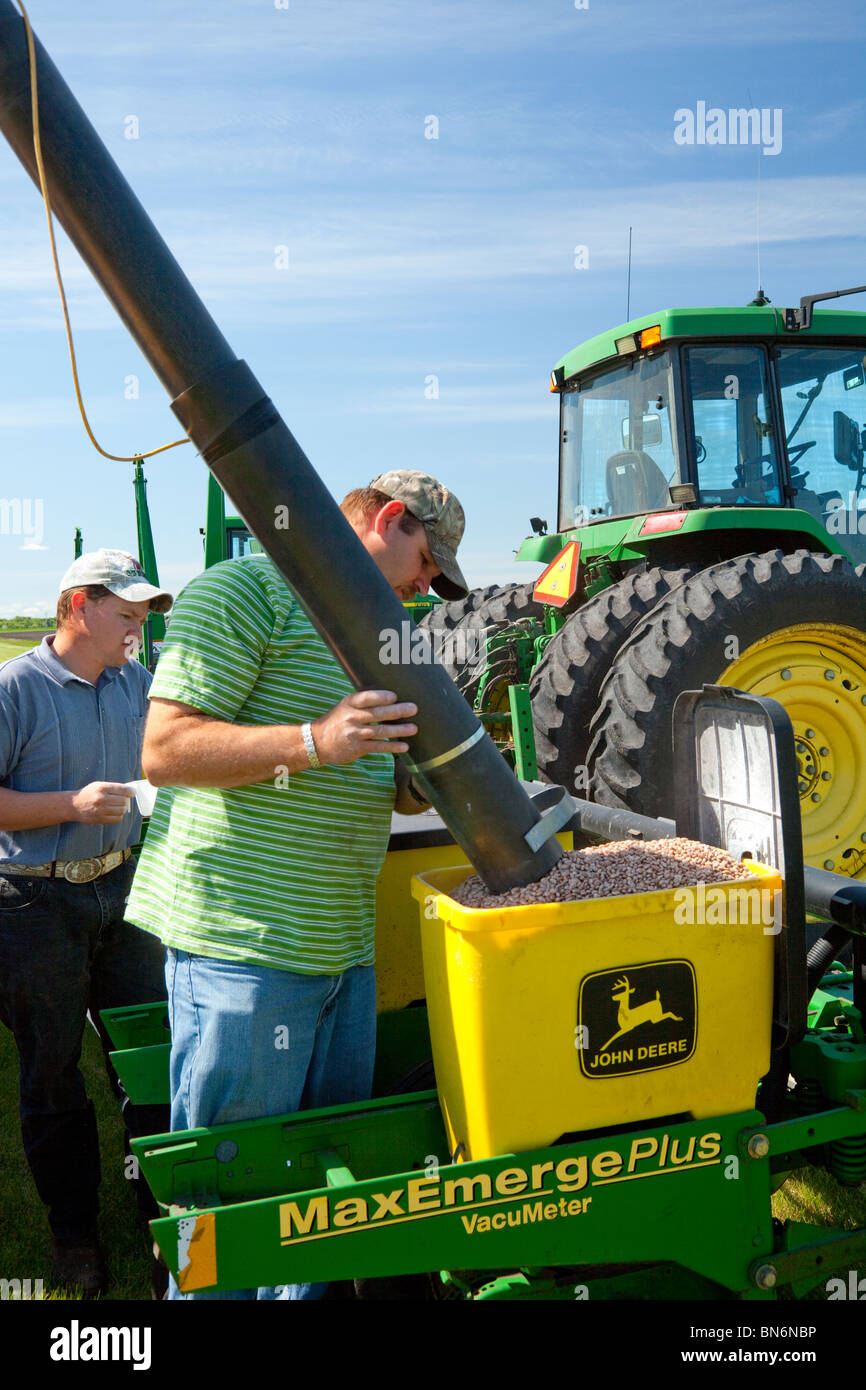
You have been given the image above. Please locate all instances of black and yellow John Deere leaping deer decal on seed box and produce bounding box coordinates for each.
[577,960,698,1077]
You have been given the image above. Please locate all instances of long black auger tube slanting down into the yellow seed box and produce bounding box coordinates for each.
[0,0,562,892]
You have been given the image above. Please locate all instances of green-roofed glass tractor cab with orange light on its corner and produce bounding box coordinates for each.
[547,300,866,564]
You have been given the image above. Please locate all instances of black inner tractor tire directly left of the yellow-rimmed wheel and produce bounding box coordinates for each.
[530,569,694,795]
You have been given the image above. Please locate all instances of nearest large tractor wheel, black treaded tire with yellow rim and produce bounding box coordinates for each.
[589,549,866,876]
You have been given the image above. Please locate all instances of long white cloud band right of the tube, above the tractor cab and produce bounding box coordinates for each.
[122,175,866,301]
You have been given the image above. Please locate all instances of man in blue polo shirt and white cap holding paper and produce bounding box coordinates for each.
[0,550,172,1295]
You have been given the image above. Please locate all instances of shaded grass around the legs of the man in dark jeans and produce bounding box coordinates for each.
[0,1024,150,1300]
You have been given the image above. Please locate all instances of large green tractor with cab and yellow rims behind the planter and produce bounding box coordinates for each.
[420,286,866,877]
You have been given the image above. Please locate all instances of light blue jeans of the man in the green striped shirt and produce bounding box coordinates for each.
[165,949,375,1300]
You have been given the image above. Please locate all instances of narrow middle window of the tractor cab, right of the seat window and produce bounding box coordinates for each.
[684,343,781,507]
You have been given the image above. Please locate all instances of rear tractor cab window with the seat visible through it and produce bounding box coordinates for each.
[559,352,680,531]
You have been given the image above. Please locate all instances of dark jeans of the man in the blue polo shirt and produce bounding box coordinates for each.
[0,859,167,1241]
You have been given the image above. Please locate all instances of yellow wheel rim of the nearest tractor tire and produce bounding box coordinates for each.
[719,623,866,877]
